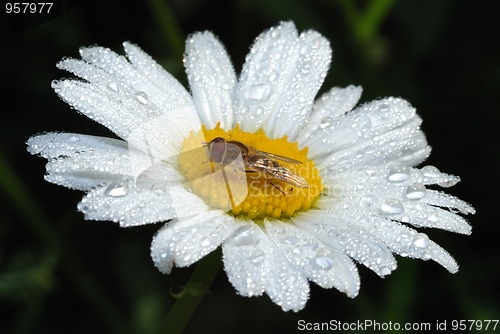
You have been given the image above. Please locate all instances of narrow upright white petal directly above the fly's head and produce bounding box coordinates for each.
[184,32,236,129]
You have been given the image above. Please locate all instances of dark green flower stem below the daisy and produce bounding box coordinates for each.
[158,250,222,334]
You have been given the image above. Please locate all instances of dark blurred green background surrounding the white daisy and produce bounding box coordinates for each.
[0,0,500,333]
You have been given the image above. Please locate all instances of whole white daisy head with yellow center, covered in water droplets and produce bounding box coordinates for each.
[27,22,474,311]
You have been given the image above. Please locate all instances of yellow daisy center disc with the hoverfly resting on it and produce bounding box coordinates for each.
[178,125,323,220]
